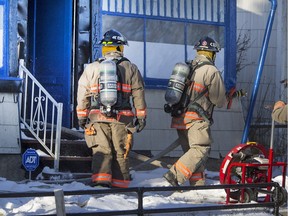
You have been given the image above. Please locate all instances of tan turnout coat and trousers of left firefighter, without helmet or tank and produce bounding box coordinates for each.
[77,51,146,188]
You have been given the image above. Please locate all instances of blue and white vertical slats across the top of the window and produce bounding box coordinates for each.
[102,0,225,22]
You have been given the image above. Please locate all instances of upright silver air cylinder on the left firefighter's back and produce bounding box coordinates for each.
[99,60,117,112]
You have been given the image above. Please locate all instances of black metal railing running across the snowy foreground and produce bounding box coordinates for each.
[0,182,280,216]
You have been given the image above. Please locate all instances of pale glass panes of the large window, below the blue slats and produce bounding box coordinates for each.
[102,15,224,87]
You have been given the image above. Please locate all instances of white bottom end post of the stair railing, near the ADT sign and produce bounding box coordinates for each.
[54,103,63,171]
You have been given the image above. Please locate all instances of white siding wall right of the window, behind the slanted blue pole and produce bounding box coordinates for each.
[237,0,287,122]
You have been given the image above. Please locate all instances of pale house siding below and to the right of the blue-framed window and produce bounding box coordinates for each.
[134,0,288,158]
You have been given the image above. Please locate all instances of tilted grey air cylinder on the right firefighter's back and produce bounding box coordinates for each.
[165,62,190,106]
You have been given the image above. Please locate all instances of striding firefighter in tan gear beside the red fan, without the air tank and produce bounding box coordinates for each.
[163,37,226,186]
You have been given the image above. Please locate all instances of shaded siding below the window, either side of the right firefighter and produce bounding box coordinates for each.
[133,89,244,158]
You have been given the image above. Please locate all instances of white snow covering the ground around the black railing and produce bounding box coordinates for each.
[0,168,288,216]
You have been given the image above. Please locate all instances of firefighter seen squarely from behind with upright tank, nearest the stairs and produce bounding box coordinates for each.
[77,29,146,188]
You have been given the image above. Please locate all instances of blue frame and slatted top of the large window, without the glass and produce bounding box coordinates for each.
[91,0,237,91]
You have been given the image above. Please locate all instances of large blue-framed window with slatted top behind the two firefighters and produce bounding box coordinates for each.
[100,0,236,90]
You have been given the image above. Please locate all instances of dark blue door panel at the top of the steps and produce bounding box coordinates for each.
[30,0,73,127]
